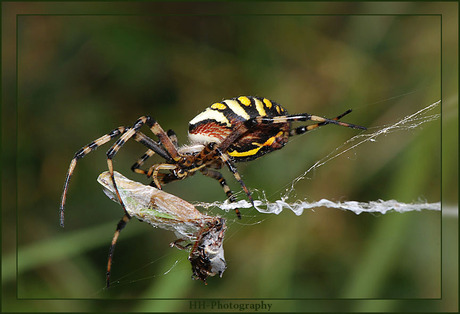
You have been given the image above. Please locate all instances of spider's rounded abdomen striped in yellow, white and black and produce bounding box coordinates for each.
[189,96,291,161]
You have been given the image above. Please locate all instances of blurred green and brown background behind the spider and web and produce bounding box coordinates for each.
[3,3,458,312]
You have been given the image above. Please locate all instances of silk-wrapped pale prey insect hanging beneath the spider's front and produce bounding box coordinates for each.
[97,171,227,287]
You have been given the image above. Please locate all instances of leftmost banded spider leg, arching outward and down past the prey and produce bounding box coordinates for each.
[60,126,129,227]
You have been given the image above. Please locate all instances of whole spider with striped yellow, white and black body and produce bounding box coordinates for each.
[61,96,365,225]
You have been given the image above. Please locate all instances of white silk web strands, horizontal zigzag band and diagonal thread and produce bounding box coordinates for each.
[195,100,441,215]
